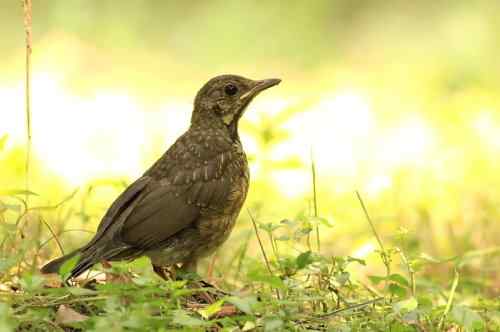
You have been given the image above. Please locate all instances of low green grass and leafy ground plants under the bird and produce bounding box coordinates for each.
[0,176,500,331]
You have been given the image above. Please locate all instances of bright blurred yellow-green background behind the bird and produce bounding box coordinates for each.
[0,0,500,283]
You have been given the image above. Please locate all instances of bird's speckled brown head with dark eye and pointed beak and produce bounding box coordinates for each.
[191,75,281,133]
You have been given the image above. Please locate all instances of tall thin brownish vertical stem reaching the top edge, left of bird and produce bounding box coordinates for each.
[23,0,32,203]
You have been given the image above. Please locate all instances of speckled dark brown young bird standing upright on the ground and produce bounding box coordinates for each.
[41,74,281,280]
